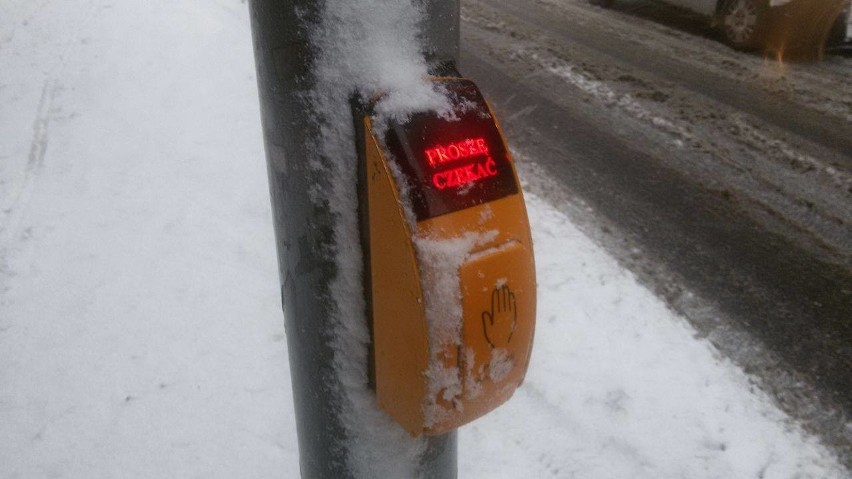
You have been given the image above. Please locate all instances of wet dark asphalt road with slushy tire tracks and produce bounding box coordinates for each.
[461,0,852,467]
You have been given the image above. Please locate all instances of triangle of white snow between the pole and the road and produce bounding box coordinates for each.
[459,189,847,479]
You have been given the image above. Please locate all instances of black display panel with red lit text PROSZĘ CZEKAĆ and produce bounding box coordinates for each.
[384,79,518,221]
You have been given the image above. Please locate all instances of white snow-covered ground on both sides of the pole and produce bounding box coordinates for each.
[0,0,848,479]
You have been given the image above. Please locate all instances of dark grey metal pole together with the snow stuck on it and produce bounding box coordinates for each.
[250,0,458,478]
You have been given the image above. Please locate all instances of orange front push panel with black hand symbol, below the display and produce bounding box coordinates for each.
[417,194,536,434]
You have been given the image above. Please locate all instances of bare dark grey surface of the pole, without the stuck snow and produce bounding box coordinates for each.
[249,0,458,479]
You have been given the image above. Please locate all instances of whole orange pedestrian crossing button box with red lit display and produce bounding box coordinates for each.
[360,78,536,436]
